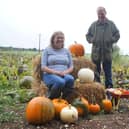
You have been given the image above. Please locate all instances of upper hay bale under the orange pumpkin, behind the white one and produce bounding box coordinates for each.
[72,57,96,79]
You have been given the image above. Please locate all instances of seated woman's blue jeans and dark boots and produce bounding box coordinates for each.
[43,74,74,98]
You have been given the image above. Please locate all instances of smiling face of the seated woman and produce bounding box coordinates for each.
[53,34,64,49]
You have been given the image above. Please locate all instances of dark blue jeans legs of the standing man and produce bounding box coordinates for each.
[94,61,113,88]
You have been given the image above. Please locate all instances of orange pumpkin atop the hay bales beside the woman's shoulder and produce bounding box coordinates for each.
[69,41,85,57]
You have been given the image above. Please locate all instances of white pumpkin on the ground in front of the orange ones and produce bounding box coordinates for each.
[60,104,78,123]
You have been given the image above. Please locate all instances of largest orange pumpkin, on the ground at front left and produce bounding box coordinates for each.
[26,97,55,124]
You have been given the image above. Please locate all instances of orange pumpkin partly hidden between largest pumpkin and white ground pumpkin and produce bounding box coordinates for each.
[52,98,69,117]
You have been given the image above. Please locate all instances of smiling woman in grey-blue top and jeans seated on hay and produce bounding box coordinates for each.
[41,31,74,99]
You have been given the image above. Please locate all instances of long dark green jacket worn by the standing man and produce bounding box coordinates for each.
[86,19,120,61]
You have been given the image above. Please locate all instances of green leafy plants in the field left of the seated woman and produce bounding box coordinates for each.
[0,50,37,122]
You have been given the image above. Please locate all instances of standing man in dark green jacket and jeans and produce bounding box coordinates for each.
[86,7,120,88]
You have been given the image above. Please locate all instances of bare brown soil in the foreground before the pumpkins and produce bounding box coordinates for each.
[0,100,129,129]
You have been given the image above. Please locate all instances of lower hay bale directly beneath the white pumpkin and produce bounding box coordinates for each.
[66,82,105,106]
